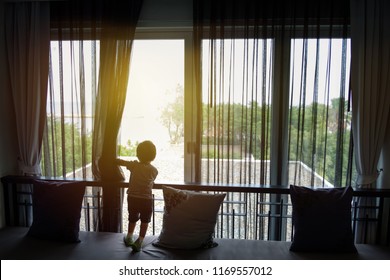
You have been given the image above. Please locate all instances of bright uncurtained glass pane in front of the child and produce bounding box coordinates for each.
[119,40,184,183]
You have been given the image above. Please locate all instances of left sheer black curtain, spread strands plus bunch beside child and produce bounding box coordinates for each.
[44,0,142,231]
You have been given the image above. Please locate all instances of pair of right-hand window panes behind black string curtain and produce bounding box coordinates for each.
[201,38,352,187]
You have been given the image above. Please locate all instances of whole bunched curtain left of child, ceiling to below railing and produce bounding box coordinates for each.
[92,0,143,232]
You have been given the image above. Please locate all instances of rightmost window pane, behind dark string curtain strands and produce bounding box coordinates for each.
[289,39,353,187]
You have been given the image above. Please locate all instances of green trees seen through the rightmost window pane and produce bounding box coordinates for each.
[289,98,351,186]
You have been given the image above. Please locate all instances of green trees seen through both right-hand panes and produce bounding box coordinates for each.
[202,98,351,185]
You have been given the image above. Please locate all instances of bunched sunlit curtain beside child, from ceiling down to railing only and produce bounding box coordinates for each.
[92,1,142,181]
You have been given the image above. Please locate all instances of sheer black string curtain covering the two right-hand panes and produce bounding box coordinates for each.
[194,0,352,239]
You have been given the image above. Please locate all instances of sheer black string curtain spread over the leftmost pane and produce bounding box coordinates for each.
[42,1,102,178]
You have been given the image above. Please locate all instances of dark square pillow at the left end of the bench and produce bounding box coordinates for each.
[27,180,85,242]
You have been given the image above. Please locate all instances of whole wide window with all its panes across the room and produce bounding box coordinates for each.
[43,28,353,239]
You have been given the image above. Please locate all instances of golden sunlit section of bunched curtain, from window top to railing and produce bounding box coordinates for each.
[93,29,133,181]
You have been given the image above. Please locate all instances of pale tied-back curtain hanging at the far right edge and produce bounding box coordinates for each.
[351,0,390,243]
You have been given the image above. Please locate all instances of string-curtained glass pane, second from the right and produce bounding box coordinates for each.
[201,39,273,184]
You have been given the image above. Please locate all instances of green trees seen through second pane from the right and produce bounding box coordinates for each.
[202,102,270,159]
